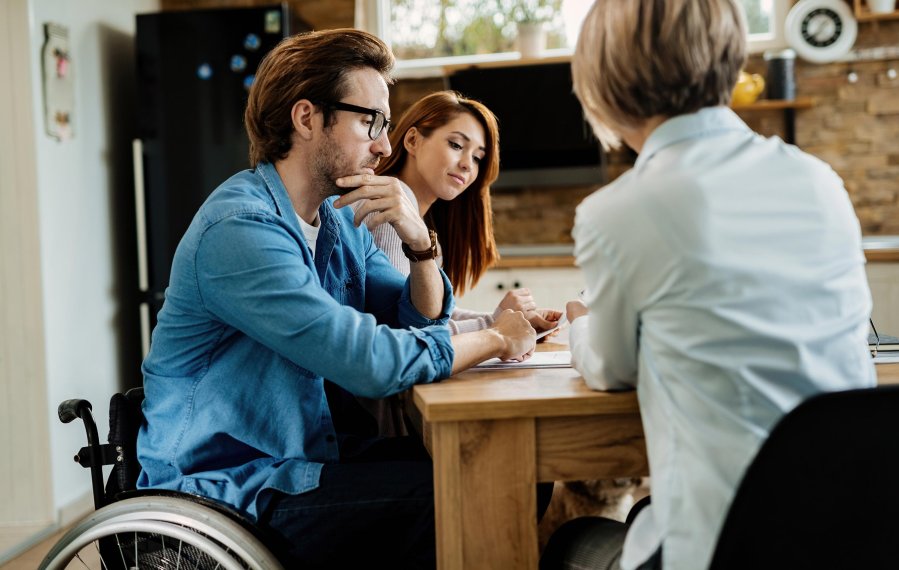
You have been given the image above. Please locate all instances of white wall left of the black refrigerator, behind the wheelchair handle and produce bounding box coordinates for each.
[30,0,159,520]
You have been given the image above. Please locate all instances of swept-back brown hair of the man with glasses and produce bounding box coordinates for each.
[244,28,394,166]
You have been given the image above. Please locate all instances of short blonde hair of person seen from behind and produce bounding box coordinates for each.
[571,0,746,149]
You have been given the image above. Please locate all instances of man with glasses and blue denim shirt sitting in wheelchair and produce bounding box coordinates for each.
[138,30,535,568]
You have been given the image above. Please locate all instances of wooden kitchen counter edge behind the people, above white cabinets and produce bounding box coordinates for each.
[496,236,899,268]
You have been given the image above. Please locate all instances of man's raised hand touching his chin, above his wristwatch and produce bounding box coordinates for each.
[334,174,431,251]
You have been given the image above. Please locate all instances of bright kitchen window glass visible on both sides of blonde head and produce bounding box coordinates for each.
[357,0,790,75]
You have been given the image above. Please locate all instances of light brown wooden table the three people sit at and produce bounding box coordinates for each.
[409,345,899,570]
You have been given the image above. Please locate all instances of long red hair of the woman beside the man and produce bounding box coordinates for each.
[377,91,499,295]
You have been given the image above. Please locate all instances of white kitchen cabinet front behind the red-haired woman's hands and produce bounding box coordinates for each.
[456,267,584,312]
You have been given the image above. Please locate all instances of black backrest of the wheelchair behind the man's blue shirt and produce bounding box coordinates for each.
[106,388,144,496]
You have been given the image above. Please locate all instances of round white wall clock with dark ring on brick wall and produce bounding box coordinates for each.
[785,0,858,63]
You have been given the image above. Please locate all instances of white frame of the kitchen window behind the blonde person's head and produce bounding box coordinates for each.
[355,0,792,78]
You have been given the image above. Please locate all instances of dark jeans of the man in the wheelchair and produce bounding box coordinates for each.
[259,438,436,568]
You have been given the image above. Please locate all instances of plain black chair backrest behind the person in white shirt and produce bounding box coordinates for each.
[711,386,899,569]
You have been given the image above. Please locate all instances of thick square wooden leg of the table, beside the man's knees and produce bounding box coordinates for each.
[432,418,538,570]
